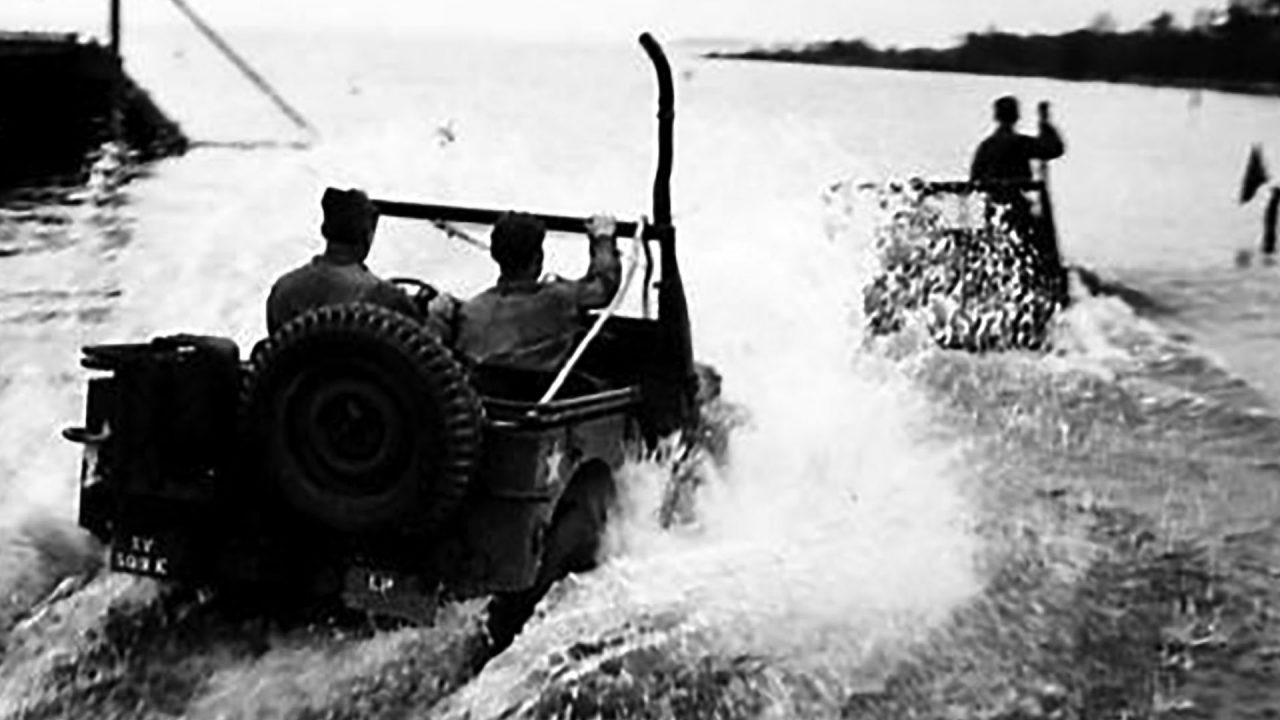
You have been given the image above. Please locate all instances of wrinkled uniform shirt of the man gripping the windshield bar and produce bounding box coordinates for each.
[454,237,622,370]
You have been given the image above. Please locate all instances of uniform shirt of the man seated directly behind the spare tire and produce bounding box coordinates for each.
[266,255,417,333]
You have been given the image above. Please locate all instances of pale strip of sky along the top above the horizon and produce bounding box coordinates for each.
[0,0,1225,45]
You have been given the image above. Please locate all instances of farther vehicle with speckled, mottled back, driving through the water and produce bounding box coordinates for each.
[860,179,1070,352]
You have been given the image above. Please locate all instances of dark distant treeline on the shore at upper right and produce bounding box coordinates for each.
[708,0,1280,94]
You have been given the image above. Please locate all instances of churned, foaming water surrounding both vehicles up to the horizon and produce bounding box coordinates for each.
[0,28,1280,717]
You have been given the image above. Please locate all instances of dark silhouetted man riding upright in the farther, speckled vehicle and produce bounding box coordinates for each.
[969,95,1066,181]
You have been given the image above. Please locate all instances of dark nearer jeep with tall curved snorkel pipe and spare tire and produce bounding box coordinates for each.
[64,33,698,638]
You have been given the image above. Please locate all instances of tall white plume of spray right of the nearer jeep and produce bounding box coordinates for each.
[435,180,979,717]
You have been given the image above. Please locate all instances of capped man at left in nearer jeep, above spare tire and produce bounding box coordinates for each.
[266,188,422,333]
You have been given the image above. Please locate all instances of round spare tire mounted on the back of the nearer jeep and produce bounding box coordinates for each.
[244,304,481,533]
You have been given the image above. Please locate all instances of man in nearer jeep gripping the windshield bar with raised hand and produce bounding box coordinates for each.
[454,213,622,372]
